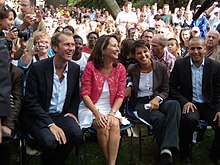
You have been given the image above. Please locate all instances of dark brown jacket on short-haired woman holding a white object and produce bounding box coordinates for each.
[127,61,169,106]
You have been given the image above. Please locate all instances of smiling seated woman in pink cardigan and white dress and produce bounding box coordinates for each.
[78,35,128,165]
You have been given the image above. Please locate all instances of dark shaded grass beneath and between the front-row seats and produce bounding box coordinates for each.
[11,129,214,165]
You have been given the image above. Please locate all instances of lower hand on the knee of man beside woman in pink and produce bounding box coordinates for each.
[50,124,66,144]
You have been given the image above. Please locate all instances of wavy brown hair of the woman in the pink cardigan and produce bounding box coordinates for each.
[88,35,118,70]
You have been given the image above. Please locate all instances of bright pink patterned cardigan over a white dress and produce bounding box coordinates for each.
[81,61,126,107]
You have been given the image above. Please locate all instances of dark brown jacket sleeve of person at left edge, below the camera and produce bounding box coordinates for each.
[3,64,24,129]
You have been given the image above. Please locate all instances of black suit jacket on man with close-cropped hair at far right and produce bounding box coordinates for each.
[170,57,220,112]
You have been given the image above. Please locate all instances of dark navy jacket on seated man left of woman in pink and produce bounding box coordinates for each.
[22,58,80,129]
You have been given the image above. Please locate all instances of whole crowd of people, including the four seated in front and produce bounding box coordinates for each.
[0,0,220,165]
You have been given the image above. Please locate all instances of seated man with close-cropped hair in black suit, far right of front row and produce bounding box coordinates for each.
[170,37,220,164]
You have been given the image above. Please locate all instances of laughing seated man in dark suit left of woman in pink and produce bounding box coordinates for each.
[22,32,82,165]
